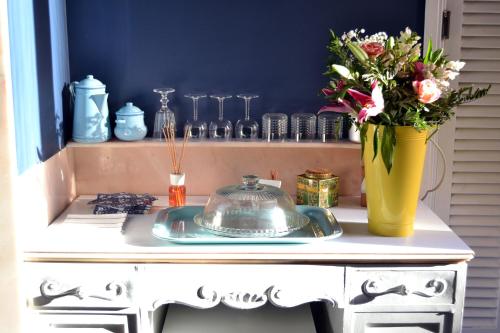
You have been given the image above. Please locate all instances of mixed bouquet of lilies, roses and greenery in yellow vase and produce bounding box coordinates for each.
[320,28,490,172]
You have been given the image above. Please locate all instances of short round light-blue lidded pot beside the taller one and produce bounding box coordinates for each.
[115,102,148,141]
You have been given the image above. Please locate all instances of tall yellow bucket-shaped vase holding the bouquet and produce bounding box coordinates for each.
[363,124,427,237]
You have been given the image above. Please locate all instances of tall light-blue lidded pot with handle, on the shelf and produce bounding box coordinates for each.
[69,75,111,143]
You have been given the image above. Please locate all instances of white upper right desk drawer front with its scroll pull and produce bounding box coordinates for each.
[346,267,456,306]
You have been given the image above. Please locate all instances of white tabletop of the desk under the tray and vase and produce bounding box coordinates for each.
[24,196,474,264]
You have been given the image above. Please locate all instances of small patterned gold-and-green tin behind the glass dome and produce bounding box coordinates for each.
[297,169,339,208]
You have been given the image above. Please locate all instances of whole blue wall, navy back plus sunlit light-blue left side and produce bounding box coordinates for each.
[8,0,425,172]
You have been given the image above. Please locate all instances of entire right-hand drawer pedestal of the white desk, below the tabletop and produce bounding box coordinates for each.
[344,263,466,333]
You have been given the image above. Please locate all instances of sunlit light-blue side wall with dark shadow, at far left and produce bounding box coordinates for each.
[8,0,69,173]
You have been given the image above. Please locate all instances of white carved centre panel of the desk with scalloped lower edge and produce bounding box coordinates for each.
[138,264,344,311]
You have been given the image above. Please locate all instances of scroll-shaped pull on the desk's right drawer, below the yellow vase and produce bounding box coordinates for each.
[361,279,448,299]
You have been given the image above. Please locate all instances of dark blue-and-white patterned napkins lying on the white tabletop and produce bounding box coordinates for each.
[89,192,158,214]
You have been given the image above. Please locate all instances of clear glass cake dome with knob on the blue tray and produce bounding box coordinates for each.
[194,175,309,237]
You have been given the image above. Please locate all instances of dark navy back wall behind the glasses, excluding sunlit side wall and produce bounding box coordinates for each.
[67,0,425,134]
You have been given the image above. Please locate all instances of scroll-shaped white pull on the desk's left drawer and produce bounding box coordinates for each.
[40,280,126,301]
